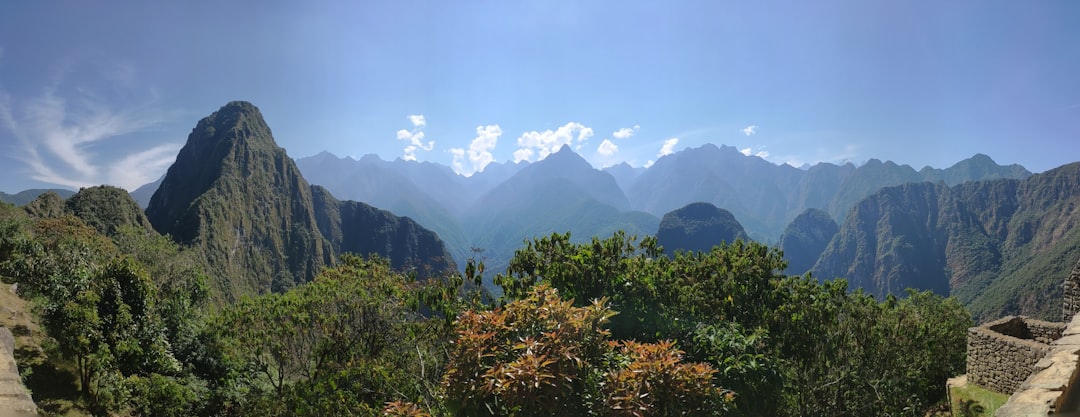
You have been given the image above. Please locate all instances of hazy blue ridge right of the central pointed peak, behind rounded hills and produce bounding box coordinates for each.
[626,144,1031,242]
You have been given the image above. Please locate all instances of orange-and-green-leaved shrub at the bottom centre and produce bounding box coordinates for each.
[443,285,731,416]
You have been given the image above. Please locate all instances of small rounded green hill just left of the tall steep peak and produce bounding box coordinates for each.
[65,186,153,237]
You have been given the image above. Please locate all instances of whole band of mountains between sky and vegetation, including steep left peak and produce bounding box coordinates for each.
[8,102,1058,318]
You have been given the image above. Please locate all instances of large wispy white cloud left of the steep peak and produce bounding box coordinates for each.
[0,82,180,190]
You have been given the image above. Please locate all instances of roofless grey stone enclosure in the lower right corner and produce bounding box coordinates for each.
[968,315,1061,394]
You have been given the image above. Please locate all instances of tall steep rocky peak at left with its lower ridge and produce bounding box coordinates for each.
[146,102,445,300]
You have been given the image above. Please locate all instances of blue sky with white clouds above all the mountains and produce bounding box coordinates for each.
[0,0,1080,192]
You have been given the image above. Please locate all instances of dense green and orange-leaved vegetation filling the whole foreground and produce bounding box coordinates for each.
[0,195,971,416]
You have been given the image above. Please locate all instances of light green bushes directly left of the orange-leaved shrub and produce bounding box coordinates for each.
[215,255,446,415]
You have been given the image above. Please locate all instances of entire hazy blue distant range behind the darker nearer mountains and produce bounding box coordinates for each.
[297,141,1031,287]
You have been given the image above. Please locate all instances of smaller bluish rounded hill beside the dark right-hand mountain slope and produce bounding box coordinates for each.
[778,209,840,275]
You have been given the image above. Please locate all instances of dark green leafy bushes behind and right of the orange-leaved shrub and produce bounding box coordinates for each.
[497,234,971,416]
